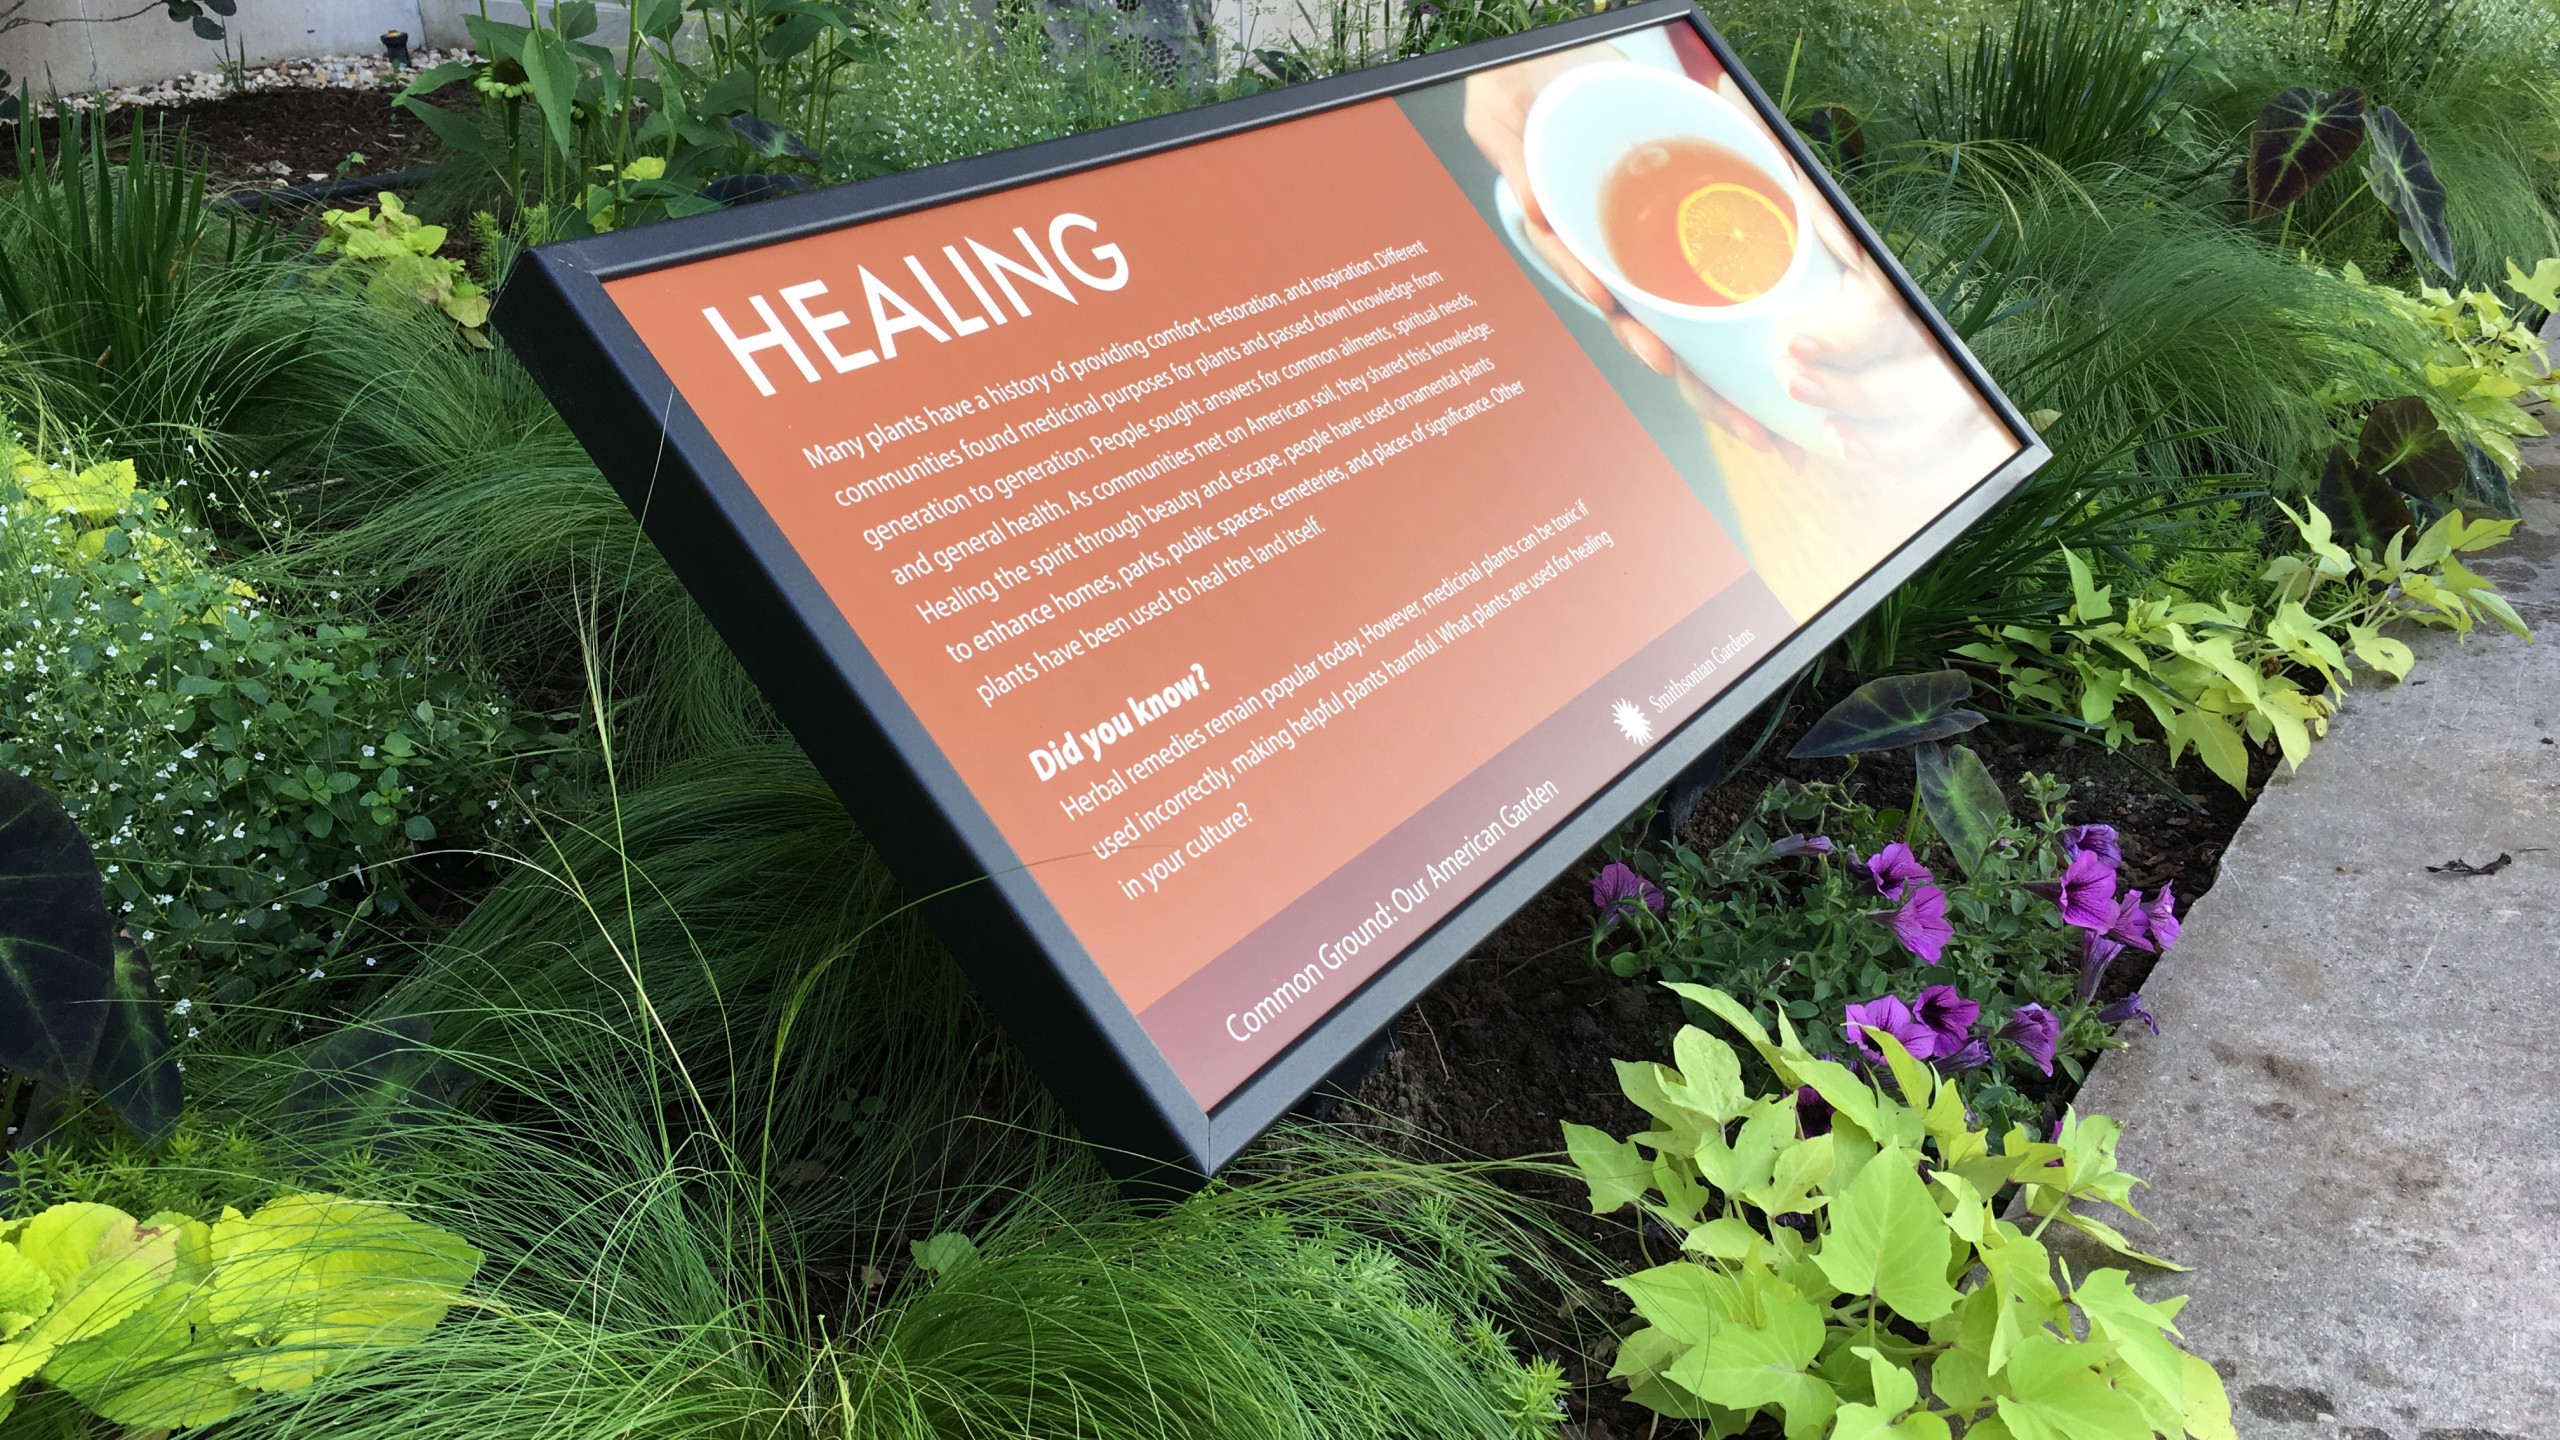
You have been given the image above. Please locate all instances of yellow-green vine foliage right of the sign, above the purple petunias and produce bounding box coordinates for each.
[1956,505,2532,792]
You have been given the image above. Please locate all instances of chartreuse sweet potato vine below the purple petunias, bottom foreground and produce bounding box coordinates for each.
[1567,984,2232,1440]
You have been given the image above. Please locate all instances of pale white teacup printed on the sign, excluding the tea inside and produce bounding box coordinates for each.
[1495,61,1843,454]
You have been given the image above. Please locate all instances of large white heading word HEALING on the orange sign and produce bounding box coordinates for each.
[701,210,1129,397]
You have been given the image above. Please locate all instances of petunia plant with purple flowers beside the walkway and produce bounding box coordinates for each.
[1592,776,2179,1122]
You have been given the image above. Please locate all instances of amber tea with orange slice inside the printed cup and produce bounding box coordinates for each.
[1600,136,1795,305]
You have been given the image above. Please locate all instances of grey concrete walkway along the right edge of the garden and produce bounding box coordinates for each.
[2079,413,2560,1440]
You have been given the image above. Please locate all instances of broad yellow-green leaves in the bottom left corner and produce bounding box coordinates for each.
[0,1194,481,1430]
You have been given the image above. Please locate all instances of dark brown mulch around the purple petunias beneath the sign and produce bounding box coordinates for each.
[1341,687,2271,1440]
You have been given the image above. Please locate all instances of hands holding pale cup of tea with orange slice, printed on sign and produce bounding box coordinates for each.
[1464,36,2007,466]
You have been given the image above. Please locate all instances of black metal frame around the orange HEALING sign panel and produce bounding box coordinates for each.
[494,0,2051,1184]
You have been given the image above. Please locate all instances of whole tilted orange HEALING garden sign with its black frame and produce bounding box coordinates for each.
[497,0,2045,1171]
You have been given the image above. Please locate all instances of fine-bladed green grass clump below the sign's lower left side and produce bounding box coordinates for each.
[64,746,1562,1440]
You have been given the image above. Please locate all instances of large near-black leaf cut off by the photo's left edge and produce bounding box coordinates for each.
[0,771,115,1089]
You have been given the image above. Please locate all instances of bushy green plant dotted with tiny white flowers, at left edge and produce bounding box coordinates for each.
[0,420,570,1027]
